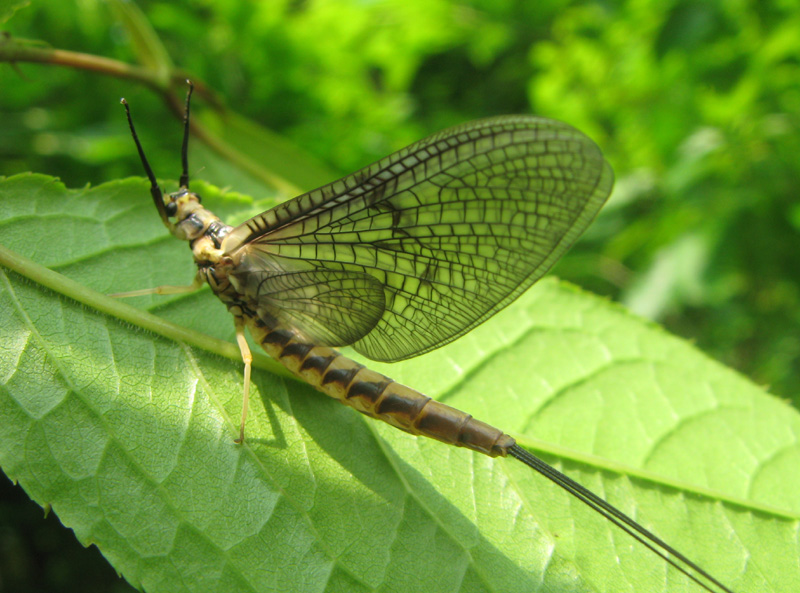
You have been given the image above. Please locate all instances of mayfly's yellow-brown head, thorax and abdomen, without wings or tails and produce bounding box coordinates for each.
[151,185,514,457]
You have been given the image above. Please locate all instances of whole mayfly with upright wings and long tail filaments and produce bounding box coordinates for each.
[115,83,733,593]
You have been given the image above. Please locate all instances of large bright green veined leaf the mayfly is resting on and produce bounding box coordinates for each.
[0,175,800,593]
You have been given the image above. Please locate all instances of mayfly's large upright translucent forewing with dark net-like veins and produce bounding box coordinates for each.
[222,116,613,361]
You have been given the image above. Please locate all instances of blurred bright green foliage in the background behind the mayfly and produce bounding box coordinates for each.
[0,0,800,592]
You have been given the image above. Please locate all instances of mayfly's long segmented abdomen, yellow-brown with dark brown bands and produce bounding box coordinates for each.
[247,318,515,457]
